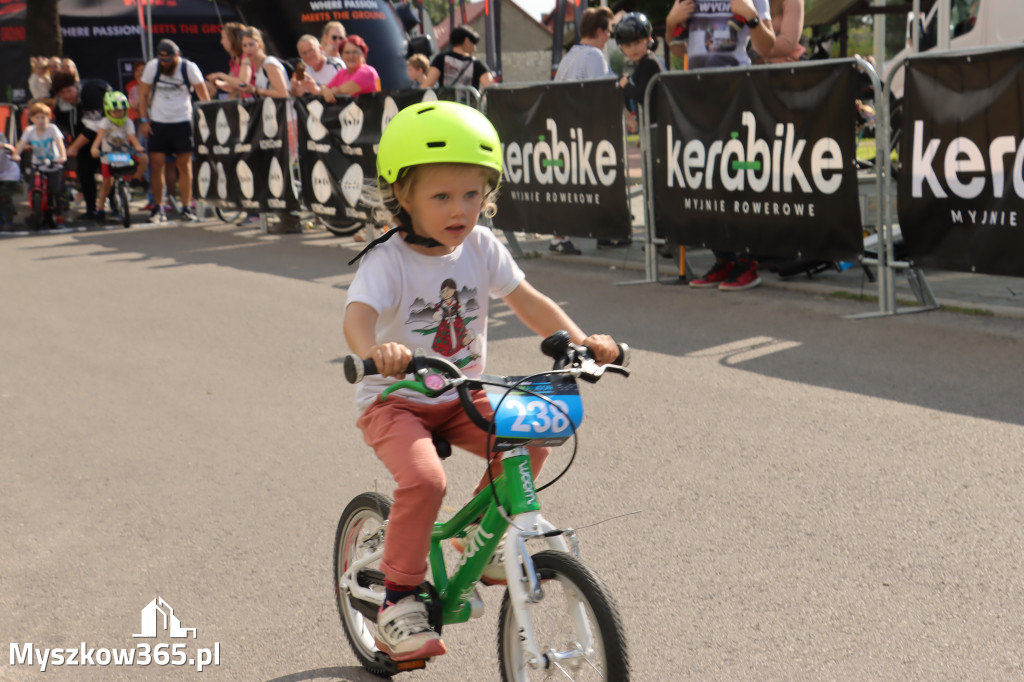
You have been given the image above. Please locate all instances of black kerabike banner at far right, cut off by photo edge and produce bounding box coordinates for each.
[897,48,1024,276]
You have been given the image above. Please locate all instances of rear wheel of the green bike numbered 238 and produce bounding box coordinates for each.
[334,493,398,677]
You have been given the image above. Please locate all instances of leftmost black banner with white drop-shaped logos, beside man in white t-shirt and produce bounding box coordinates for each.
[194,97,299,212]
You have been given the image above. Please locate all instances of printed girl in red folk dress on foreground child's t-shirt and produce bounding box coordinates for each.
[407,279,480,368]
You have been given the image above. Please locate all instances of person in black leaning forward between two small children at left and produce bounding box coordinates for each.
[47,71,112,220]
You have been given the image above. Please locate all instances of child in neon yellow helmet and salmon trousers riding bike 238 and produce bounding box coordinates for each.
[344,101,618,660]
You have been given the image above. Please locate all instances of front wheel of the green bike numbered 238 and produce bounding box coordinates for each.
[498,550,630,682]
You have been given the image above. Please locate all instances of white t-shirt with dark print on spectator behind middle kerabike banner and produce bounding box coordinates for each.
[686,0,771,69]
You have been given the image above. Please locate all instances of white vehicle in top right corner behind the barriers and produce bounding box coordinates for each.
[885,0,1024,97]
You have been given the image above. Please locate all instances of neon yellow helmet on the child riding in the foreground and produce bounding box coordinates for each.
[377,101,502,183]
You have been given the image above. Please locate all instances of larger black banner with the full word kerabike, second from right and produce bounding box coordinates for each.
[650,59,863,260]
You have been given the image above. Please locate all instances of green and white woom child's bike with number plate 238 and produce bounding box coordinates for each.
[334,332,630,682]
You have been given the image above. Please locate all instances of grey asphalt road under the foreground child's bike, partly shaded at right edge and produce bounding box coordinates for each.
[0,226,1024,682]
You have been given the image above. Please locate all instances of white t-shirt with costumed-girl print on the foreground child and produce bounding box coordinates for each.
[346,225,525,410]
